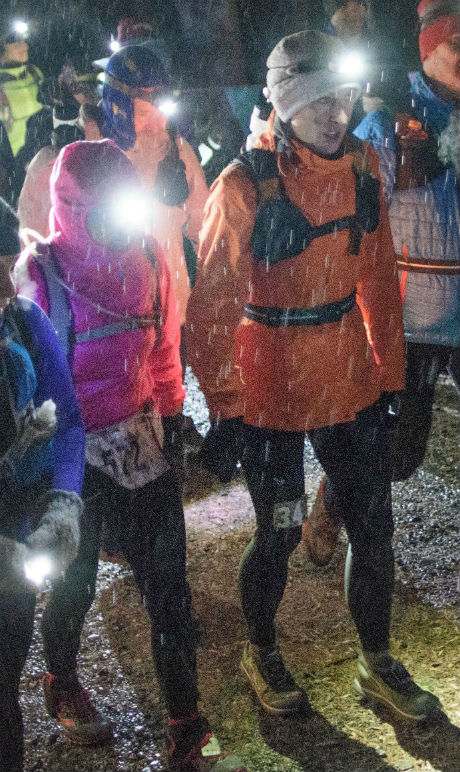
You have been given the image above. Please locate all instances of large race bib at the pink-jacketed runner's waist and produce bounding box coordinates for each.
[86,410,170,490]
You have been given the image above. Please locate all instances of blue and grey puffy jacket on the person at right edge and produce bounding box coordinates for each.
[356,73,460,346]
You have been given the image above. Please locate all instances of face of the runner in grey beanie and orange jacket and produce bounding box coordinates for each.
[291,88,359,156]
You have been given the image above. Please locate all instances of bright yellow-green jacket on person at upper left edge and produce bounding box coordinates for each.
[0,63,43,155]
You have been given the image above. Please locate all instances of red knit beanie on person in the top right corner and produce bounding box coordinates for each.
[417,0,460,62]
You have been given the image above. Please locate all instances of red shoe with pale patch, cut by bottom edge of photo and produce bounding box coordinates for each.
[166,713,246,772]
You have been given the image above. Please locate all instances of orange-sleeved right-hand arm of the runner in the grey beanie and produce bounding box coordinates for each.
[357,151,405,391]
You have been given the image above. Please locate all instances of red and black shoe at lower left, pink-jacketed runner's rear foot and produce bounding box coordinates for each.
[42,673,113,745]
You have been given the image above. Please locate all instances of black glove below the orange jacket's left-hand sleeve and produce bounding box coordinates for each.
[198,417,243,483]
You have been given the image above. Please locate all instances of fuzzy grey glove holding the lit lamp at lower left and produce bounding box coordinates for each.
[26,490,83,575]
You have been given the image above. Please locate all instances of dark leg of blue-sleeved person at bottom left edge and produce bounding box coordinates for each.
[0,588,35,772]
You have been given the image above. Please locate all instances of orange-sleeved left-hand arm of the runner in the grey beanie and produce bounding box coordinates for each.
[187,169,256,419]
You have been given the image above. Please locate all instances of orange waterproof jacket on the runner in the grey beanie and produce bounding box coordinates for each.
[187,121,404,431]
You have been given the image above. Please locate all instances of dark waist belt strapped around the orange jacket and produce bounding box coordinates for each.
[244,290,356,327]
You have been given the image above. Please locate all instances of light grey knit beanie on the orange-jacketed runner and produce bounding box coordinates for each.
[264,30,360,123]
